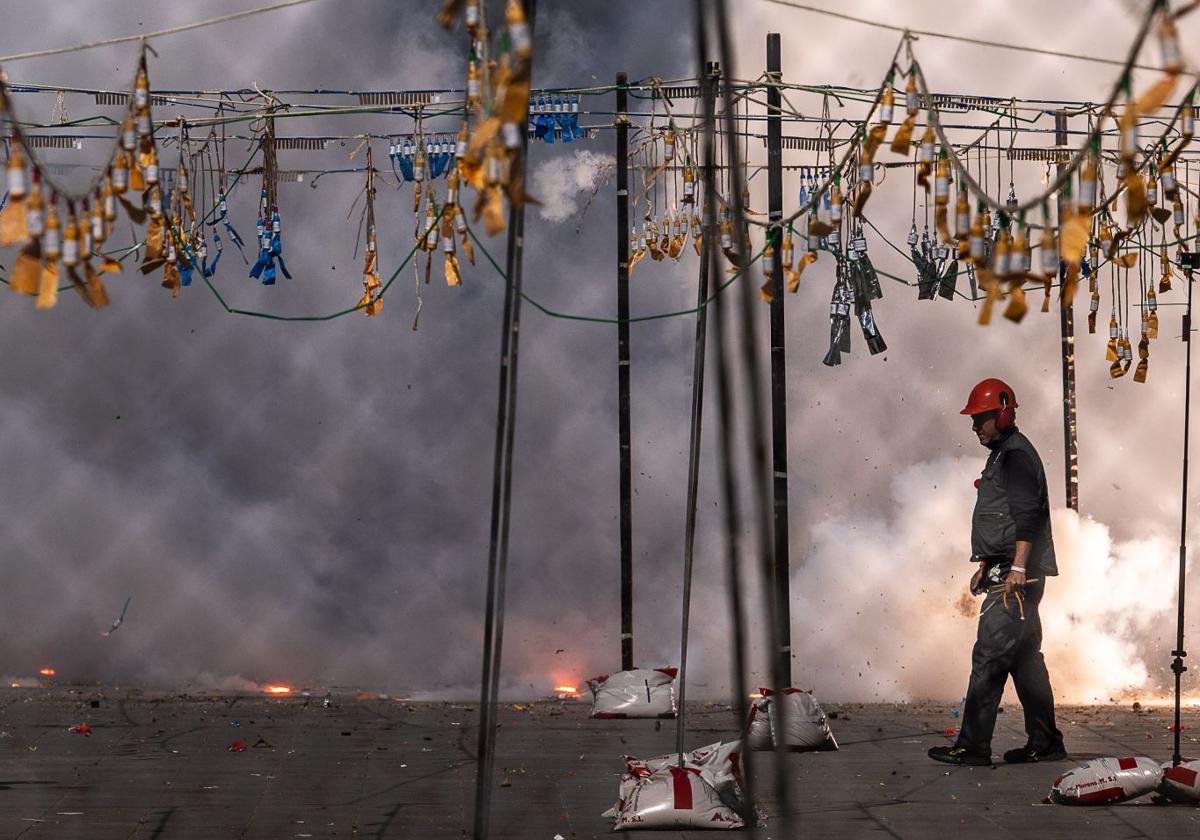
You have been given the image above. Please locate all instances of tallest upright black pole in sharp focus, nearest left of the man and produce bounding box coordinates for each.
[767,32,792,690]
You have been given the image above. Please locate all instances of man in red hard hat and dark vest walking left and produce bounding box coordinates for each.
[929,379,1067,764]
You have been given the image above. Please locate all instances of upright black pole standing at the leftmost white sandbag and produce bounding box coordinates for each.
[617,73,634,671]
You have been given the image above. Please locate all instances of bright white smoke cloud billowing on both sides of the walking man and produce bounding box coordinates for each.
[792,458,1175,702]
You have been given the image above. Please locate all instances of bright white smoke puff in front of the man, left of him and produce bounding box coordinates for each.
[792,458,979,702]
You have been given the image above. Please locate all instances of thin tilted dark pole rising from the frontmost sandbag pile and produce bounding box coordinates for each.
[676,61,721,767]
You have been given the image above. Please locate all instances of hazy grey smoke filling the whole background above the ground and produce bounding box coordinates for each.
[0,0,1198,700]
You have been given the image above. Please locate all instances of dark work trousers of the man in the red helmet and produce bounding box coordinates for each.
[955,581,1062,755]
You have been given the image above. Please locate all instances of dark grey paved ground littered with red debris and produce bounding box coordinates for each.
[0,688,1200,840]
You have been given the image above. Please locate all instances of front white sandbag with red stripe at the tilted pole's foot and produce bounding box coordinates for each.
[613,767,742,832]
